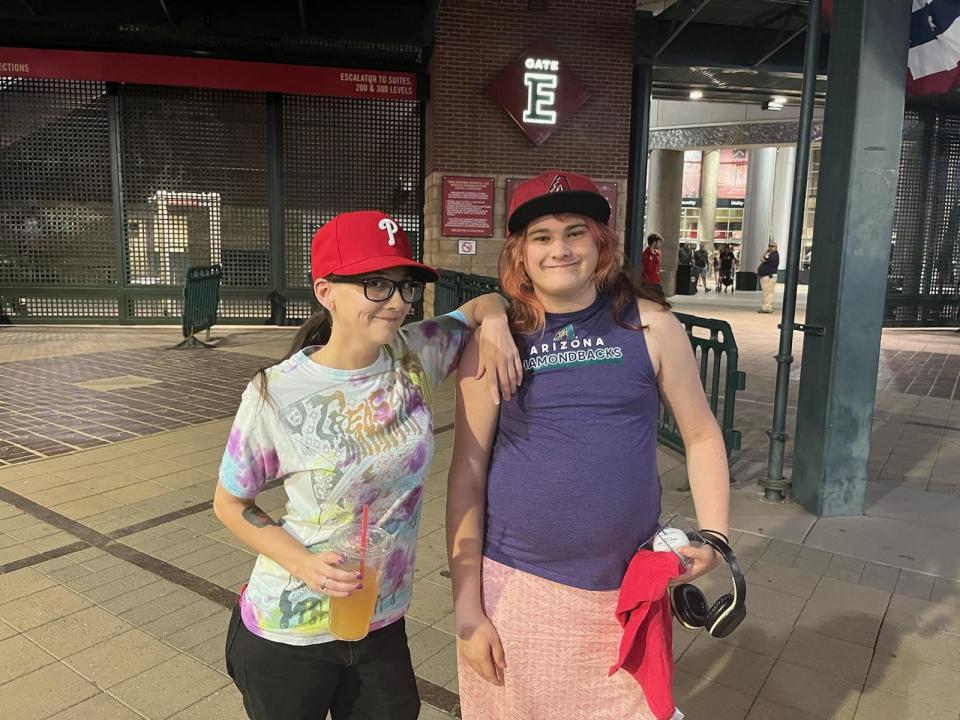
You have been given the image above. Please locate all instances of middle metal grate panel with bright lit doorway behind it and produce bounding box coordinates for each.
[120,86,270,288]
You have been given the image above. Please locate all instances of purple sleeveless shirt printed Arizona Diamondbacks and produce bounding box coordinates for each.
[484,296,660,590]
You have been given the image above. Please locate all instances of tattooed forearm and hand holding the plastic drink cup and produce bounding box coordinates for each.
[213,483,362,597]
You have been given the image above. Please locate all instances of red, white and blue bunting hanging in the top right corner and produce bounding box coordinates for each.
[823,0,960,95]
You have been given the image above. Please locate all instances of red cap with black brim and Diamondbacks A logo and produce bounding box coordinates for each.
[507,170,610,235]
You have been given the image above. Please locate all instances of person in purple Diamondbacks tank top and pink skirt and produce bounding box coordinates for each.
[447,171,729,720]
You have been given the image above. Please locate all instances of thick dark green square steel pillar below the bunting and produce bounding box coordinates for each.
[792,0,911,515]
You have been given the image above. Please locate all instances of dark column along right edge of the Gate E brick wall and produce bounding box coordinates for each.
[623,64,653,268]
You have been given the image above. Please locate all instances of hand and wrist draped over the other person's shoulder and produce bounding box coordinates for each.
[460,293,523,404]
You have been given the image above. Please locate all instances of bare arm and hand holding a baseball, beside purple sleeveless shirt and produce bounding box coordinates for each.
[644,311,730,582]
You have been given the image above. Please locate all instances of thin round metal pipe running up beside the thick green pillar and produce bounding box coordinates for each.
[760,0,820,502]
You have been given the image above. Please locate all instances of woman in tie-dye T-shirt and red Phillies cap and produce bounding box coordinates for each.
[214,211,521,720]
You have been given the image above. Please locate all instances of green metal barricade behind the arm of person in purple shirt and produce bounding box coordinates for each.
[657,313,747,457]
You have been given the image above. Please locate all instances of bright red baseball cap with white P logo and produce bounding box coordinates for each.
[310,210,440,282]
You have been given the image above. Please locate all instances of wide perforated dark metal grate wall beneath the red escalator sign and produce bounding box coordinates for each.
[0,78,423,324]
